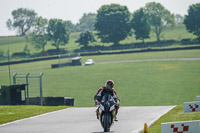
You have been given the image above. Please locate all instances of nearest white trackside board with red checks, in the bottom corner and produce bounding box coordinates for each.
[161,120,200,133]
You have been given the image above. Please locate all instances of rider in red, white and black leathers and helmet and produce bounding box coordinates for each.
[94,80,120,121]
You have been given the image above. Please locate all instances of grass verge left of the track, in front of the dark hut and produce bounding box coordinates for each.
[0,105,69,124]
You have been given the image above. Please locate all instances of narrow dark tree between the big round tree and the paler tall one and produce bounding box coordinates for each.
[132,8,151,42]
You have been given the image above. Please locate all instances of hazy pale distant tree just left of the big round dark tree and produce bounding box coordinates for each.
[76,13,96,31]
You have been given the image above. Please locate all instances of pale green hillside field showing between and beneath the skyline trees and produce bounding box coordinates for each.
[0,24,196,59]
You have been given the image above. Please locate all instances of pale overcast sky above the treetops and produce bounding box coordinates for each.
[0,0,200,36]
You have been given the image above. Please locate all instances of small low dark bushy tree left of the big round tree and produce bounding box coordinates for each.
[76,31,95,47]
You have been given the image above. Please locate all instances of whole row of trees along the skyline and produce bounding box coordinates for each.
[7,2,200,53]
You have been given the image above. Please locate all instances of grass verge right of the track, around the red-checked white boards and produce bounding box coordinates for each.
[141,105,200,133]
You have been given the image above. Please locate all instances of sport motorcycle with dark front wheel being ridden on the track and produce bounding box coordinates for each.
[98,93,116,132]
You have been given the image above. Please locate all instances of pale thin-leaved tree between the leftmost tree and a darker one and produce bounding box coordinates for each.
[30,17,48,53]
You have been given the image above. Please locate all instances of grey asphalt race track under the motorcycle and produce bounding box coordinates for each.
[0,106,175,133]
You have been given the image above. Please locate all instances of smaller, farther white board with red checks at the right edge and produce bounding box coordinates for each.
[184,101,200,113]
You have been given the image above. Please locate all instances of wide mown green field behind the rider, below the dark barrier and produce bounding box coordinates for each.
[0,50,200,107]
